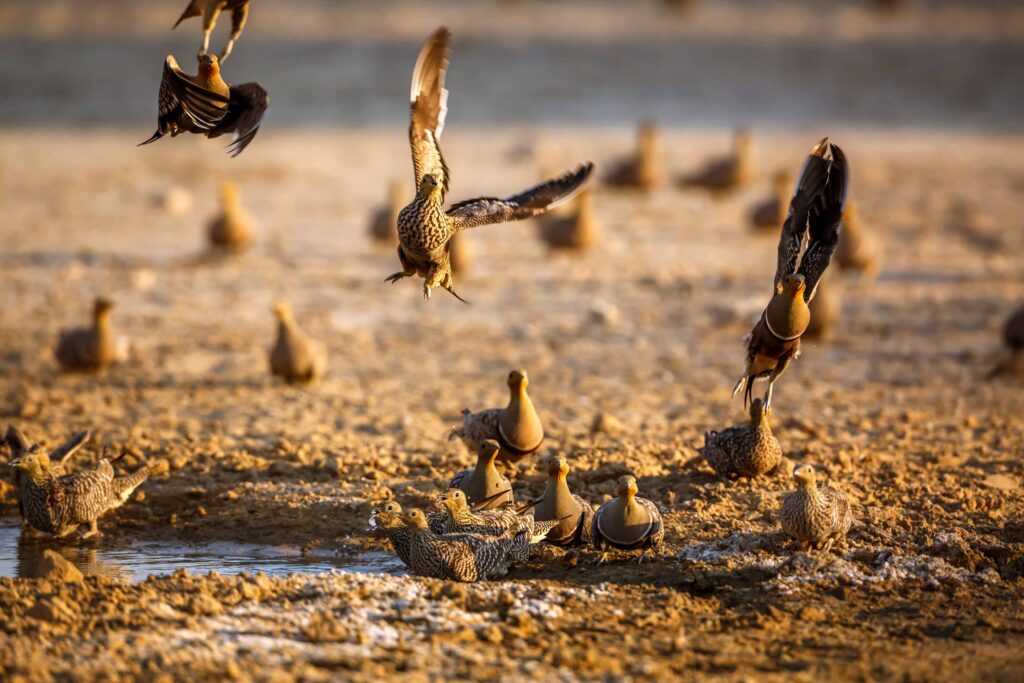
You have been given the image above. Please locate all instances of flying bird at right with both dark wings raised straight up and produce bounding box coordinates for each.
[732,138,849,409]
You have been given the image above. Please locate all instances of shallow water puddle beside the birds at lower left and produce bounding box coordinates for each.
[0,524,404,581]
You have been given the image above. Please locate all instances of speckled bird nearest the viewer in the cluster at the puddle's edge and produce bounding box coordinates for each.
[403,510,525,582]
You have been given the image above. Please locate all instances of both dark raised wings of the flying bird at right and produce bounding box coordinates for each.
[773,139,848,301]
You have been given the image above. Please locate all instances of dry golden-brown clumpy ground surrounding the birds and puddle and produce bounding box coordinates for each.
[0,3,1024,681]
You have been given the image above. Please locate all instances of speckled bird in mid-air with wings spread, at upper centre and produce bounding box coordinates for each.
[386,28,594,300]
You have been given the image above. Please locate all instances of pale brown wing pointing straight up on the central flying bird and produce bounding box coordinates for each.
[409,27,452,200]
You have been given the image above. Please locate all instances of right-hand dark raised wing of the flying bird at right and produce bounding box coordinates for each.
[800,144,849,301]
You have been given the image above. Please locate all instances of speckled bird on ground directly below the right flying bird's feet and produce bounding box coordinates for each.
[701,398,782,479]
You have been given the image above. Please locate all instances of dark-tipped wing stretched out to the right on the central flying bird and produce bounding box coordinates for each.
[447,162,594,230]
